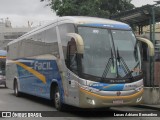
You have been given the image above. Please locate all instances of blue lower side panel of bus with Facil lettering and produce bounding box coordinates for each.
[17,59,64,101]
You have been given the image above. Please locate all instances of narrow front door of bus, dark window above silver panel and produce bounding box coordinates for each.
[66,38,79,106]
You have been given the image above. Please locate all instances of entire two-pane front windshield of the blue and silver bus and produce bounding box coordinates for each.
[78,26,141,78]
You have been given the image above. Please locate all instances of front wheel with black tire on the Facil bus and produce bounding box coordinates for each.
[53,86,64,111]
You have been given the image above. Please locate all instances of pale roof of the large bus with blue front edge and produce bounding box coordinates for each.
[8,16,131,45]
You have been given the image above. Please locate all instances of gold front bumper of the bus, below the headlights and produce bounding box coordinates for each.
[80,88,144,108]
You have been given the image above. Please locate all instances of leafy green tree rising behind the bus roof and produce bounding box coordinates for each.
[40,0,134,18]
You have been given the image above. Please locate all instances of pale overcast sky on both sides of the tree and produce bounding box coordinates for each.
[0,0,155,27]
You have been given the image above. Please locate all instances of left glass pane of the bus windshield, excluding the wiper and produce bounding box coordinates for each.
[79,27,116,78]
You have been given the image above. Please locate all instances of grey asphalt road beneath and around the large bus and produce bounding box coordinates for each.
[0,86,159,120]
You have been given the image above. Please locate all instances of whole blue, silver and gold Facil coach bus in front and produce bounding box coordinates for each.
[6,17,153,110]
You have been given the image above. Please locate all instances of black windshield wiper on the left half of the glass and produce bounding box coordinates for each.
[101,49,115,81]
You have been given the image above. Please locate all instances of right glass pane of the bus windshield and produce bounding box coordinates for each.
[111,30,140,77]
